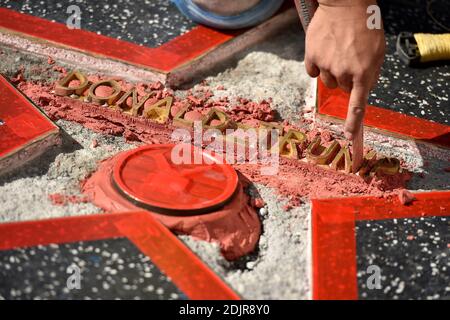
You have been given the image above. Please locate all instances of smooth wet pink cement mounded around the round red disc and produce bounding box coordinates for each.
[82,153,261,260]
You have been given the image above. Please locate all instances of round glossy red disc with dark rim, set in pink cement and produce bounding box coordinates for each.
[112,144,238,215]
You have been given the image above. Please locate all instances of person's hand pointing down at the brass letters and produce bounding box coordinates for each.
[305,0,385,140]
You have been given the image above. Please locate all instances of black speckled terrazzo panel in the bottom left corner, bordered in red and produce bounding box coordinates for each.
[0,238,186,300]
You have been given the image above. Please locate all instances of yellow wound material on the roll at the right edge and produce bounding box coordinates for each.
[414,33,450,62]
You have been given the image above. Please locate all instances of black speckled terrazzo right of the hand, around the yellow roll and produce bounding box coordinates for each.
[369,0,450,125]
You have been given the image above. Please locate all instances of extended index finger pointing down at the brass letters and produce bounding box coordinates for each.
[344,84,369,140]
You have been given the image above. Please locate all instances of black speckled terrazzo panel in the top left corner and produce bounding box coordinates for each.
[0,0,195,47]
